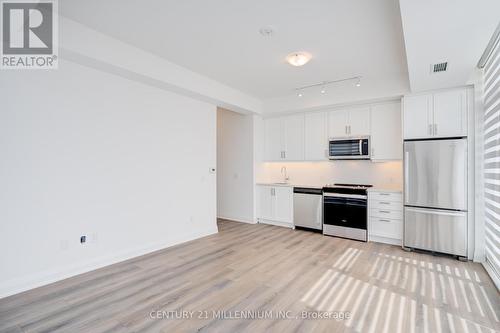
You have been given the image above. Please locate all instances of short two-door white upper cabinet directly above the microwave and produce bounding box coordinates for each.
[328,106,370,138]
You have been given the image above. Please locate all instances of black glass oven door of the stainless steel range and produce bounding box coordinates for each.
[323,193,367,230]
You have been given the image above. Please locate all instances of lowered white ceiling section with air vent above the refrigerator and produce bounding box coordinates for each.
[400,0,500,92]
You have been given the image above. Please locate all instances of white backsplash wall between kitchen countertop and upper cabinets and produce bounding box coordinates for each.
[257,161,403,189]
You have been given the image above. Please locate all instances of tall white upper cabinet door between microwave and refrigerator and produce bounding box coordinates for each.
[371,103,403,160]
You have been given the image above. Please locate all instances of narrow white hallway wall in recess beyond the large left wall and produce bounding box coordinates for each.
[217,108,254,223]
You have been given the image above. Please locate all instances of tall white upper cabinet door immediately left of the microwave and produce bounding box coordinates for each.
[304,112,328,161]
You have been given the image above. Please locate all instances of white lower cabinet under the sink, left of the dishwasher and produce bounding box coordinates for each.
[257,185,293,228]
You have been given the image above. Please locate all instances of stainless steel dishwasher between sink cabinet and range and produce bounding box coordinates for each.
[293,187,323,230]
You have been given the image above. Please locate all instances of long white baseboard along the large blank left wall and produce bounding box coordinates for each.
[0,226,218,299]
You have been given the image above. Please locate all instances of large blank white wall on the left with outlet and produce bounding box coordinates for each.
[0,61,217,297]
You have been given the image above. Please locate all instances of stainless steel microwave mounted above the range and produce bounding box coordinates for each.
[328,136,370,160]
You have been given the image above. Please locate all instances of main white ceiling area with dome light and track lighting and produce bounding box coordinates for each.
[59,0,408,104]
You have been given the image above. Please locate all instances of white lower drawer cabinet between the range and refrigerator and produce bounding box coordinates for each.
[368,191,403,245]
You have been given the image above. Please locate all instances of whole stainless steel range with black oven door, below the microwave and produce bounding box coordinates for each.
[323,184,372,242]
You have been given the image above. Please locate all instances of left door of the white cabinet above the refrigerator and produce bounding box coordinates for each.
[403,94,433,139]
